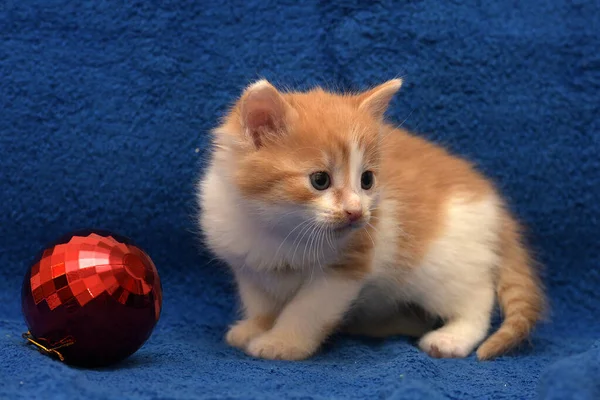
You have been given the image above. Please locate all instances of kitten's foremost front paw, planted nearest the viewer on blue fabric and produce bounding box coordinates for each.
[247,333,317,361]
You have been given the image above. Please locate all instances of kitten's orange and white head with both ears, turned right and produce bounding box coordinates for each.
[216,79,402,238]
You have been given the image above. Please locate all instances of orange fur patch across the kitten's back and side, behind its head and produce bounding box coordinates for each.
[380,125,494,265]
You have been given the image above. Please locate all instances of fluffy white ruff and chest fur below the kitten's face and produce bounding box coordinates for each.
[198,162,323,297]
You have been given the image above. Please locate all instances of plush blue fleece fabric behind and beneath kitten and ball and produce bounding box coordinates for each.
[0,0,600,400]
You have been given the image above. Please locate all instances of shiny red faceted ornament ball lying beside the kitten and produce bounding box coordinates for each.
[21,230,162,367]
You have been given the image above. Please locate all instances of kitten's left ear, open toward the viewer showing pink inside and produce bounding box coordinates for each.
[240,79,292,148]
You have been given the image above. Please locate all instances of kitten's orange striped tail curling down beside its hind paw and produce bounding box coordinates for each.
[477,214,545,360]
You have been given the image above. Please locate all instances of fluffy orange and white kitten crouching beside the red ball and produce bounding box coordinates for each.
[198,79,544,360]
